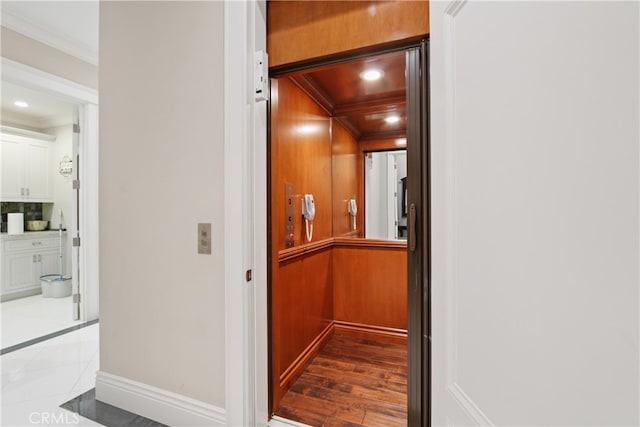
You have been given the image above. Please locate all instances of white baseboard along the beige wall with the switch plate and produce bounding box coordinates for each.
[96,371,227,427]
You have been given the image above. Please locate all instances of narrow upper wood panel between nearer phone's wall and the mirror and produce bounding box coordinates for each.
[331,120,364,237]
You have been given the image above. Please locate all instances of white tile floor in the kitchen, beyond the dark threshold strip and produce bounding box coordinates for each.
[0,295,83,348]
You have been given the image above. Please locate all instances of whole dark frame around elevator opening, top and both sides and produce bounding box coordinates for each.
[267,39,431,427]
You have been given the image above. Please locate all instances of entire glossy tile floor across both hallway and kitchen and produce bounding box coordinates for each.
[0,295,303,427]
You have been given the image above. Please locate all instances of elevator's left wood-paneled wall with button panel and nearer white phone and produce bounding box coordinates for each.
[270,77,333,407]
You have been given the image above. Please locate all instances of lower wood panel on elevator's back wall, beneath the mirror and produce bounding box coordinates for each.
[333,239,407,331]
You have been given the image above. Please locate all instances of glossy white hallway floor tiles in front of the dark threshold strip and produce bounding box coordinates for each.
[0,326,102,427]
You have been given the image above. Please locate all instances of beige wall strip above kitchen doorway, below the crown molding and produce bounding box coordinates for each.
[0,27,98,89]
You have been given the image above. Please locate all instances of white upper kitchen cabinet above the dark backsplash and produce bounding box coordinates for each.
[0,129,54,202]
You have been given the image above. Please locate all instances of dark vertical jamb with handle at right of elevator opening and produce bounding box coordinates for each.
[407,40,431,427]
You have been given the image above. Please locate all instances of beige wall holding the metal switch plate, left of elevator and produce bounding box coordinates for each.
[100,2,225,407]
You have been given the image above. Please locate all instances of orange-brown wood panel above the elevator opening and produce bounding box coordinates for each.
[267,1,429,67]
